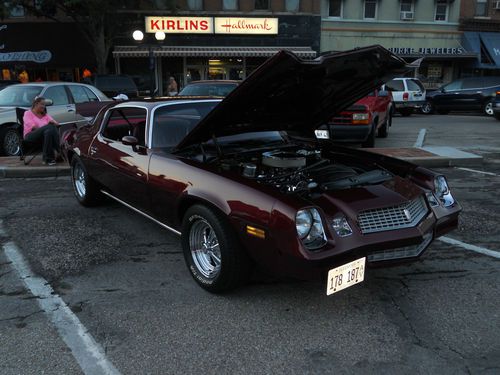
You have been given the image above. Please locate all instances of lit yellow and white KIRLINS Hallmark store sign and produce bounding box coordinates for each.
[146,17,278,35]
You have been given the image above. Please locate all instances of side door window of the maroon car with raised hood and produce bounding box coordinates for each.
[101,107,147,146]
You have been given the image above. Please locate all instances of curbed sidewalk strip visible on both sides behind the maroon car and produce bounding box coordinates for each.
[0,147,483,178]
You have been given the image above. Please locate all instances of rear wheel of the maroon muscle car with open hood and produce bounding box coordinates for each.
[71,156,103,207]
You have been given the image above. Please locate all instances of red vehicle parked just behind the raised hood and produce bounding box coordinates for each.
[328,89,394,147]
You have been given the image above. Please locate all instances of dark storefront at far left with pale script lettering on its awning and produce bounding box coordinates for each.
[0,20,95,82]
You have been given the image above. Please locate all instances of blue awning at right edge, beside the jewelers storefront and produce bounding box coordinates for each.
[463,31,500,69]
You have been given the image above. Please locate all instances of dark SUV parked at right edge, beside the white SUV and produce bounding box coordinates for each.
[421,76,500,116]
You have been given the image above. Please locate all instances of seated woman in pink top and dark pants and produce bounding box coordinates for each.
[23,97,60,165]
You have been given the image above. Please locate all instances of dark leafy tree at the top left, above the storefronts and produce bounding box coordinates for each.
[0,0,145,73]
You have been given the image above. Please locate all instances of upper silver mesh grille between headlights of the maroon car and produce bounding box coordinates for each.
[358,196,428,234]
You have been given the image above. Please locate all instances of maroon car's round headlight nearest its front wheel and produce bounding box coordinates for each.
[295,208,326,250]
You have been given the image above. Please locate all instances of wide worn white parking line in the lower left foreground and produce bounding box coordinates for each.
[0,242,120,375]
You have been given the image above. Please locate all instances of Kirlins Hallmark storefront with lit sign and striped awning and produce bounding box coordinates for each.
[113,14,320,95]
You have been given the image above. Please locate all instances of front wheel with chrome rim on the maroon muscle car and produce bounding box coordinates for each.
[181,205,252,293]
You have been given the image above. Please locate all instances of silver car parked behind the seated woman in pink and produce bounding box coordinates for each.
[0,82,111,156]
